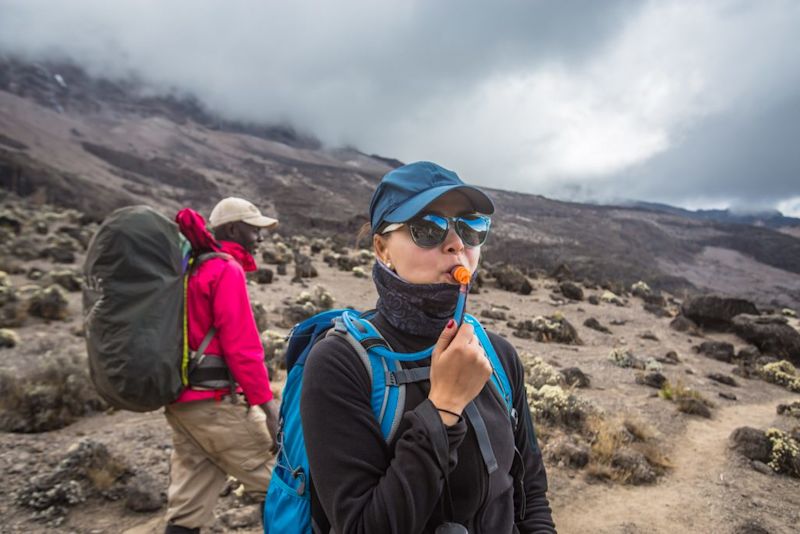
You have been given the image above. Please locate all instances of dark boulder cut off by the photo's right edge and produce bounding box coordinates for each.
[733,315,800,365]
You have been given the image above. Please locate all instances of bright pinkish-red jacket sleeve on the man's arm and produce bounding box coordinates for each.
[212,261,272,406]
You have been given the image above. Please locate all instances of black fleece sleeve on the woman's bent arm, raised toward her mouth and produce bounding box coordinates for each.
[300,337,466,534]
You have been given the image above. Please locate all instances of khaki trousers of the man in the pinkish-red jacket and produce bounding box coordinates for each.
[165,398,275,528]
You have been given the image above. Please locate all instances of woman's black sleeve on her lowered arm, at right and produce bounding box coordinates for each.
[489,334,556,534]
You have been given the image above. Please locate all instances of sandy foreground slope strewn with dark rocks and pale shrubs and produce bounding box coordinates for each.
[0,195,800,534]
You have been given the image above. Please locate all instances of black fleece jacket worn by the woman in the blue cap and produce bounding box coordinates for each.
[300,315,555,534]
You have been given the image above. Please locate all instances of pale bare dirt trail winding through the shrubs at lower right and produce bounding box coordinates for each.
[555,397,796,534]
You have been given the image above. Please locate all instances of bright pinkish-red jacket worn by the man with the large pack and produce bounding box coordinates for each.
[176,242,272,405]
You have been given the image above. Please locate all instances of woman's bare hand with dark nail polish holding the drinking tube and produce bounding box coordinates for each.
[428,319,492,425]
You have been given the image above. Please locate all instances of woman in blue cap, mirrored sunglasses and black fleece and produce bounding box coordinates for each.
[301,162,555,534]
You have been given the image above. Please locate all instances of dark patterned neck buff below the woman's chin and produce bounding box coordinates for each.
[372,261,466,338]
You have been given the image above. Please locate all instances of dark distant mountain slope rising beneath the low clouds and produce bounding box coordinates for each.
[0,58,800,306]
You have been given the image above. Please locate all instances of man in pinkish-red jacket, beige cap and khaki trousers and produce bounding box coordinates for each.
[165,197,278,534]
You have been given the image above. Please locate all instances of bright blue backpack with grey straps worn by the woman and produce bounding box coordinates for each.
[264,309,518,534]
